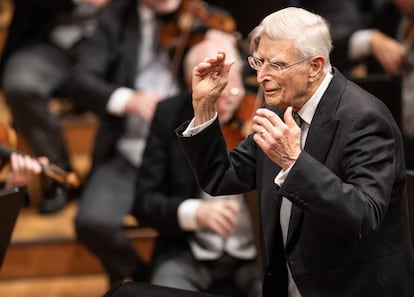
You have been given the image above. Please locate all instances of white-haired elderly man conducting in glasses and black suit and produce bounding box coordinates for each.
[176,7,414,297]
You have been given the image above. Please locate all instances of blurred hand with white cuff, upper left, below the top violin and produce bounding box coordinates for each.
[125,91,161,122]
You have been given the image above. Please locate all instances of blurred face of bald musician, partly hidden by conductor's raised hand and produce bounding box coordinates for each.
[216,65,245,124]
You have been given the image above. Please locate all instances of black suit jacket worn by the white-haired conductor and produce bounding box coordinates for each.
[177,70,414,297]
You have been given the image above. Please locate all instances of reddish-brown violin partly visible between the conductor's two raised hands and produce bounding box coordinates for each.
[221,92,263,150]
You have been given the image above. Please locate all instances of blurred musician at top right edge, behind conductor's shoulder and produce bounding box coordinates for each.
[350,0,414,170]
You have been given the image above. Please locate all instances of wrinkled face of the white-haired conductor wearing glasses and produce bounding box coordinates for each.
[252,35,312,111]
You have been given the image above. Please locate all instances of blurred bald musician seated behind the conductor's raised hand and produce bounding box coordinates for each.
[134,31,261,297]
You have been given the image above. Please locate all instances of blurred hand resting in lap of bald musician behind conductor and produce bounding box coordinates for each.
[196,198,240,237]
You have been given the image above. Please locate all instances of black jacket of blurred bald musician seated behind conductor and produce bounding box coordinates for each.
[133,93,201,262]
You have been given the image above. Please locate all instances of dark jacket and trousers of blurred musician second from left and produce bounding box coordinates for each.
[68,0,170,285]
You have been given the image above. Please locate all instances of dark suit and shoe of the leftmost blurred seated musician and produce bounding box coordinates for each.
[0,0,81,213]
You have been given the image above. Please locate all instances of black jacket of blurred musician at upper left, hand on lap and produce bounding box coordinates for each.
[68,0,187,162]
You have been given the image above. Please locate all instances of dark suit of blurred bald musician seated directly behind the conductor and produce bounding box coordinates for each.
[133,88,261,296]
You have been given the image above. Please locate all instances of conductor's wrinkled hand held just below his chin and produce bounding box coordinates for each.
[252,107,302,170]
